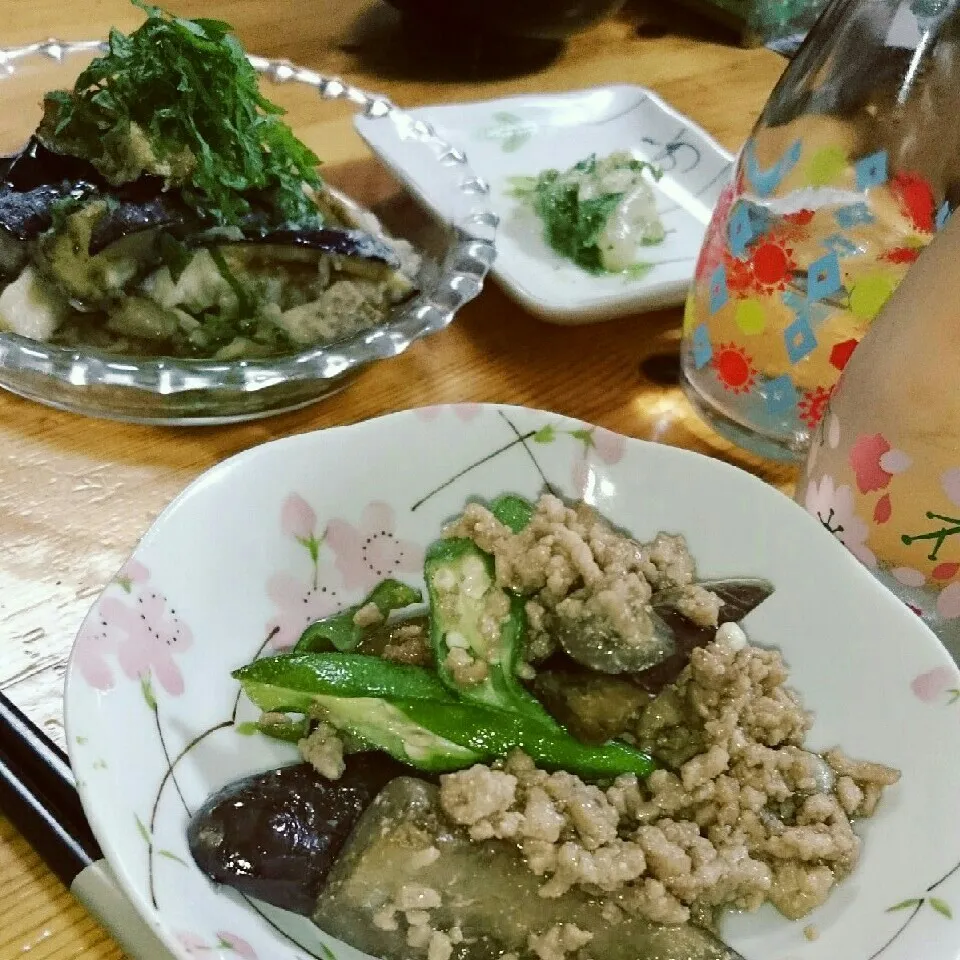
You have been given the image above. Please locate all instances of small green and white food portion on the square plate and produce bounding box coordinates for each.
[511,152,666,276]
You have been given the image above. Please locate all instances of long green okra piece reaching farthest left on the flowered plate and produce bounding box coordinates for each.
[232,653,453,713]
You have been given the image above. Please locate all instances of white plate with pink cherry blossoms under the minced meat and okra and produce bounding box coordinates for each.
[66,405,960,960]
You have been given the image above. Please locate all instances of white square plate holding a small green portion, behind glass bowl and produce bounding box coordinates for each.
[356,84,733,324]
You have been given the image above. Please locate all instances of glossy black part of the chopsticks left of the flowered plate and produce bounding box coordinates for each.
[0,693,103,887]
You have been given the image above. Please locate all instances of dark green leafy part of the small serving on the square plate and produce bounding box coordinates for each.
[510,154,663,274]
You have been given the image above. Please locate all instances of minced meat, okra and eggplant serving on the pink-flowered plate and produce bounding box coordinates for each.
[190,495,899,960]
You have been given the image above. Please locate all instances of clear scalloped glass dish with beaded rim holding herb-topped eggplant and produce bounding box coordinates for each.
[0,40,497,425]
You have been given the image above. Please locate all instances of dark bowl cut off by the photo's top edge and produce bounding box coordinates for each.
[387,0,626,40]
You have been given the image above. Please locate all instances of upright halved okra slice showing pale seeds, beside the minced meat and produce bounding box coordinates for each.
[424,538,558,729]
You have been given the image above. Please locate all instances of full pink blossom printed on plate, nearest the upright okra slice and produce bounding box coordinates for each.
[326,501,424,591]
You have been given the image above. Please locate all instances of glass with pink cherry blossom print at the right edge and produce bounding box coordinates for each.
[796,206,960,661]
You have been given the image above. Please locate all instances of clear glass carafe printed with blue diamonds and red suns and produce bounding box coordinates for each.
[681,0,960,460]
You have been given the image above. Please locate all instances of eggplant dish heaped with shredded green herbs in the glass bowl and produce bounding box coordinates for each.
[0,0,419,360]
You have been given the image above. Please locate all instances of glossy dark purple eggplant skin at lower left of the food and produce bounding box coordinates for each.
[187,753,409,916]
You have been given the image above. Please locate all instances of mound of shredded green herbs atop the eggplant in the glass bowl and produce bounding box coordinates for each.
[39,0,322,225]
